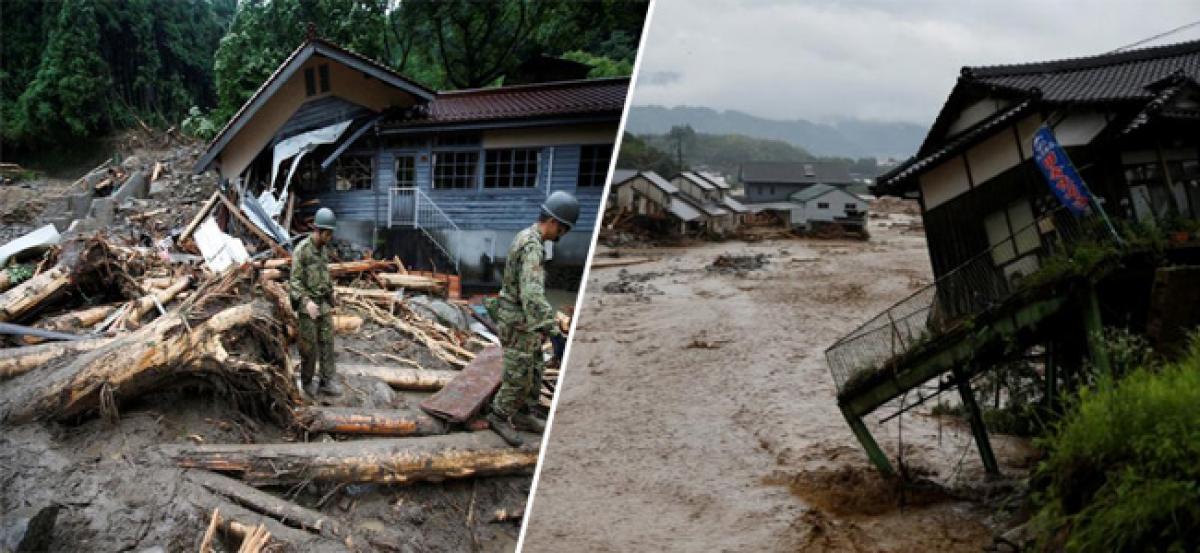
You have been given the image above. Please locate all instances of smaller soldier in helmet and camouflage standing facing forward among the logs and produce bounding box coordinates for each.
[288,208,342,398]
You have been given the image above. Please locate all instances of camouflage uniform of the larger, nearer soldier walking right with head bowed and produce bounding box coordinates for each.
[487,224,562,417]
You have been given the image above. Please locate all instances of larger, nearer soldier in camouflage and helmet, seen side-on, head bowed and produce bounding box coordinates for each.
[486,192,580,446]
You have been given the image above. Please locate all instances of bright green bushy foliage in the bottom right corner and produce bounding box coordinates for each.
[1034,337,1200,552]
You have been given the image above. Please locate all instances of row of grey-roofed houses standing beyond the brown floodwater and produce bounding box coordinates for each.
[610,162,868,234]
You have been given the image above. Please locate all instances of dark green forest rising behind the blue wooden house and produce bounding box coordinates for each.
[0,0,647,161]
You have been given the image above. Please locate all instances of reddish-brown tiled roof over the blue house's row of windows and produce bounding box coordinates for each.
[385,78,629,127]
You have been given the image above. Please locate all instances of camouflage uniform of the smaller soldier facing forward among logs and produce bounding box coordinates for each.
[288,235,337,384]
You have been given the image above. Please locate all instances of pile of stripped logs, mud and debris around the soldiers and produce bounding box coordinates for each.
[0,132,540,552]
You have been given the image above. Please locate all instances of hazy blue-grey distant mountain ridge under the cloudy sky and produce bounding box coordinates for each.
[625,106,925,158]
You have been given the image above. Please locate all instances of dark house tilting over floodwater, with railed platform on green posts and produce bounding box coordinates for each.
[830,41,1200,473]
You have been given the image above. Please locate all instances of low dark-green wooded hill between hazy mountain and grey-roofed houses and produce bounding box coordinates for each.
[617,126,880,180]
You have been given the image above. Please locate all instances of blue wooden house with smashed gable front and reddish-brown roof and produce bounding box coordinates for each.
[194,38,629,281]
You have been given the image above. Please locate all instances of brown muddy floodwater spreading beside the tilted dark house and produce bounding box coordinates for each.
[524,214,1033,552]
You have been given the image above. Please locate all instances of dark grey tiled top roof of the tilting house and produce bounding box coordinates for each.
[962,41,1200,102]
